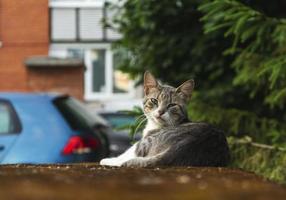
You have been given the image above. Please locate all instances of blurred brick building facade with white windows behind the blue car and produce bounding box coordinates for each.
[0,0,142,110]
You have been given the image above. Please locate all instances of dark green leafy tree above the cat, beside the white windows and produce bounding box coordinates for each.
[107,0,232,86]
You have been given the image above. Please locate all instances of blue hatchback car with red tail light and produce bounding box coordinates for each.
[0,93,109,164]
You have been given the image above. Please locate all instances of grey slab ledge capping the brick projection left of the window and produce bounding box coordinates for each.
[25,56,84,68]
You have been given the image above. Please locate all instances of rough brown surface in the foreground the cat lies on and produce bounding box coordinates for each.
[0,163,286,200]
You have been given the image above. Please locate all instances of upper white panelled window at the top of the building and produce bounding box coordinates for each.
[50,5,121,42]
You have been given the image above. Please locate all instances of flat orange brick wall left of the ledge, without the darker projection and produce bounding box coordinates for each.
[0,0,49,91]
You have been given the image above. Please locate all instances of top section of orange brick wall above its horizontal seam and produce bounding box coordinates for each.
[0,0,49,44]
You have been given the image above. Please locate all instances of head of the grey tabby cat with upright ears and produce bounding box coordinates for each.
[143,71,194,127]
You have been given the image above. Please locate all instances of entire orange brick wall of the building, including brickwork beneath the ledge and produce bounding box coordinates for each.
[0,0,84,99]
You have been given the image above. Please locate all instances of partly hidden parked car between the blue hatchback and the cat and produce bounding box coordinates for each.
[99,112,141,156]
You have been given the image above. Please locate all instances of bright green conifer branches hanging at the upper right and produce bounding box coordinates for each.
[199,0,286,108]
